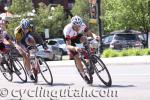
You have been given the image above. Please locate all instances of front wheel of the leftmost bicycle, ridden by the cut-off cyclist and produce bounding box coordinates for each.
[12,59,27,82]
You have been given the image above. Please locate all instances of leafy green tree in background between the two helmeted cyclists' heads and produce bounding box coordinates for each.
[33,3,67,37]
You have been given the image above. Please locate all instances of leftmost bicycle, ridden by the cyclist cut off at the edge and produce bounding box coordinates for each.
[0,47,27,82]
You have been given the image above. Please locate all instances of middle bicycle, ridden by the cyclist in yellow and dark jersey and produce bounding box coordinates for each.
[27,44,53,85]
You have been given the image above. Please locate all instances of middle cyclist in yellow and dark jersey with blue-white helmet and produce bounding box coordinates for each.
[14,19,36,80]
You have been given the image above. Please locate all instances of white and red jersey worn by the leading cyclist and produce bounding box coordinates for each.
[63,23,87,40]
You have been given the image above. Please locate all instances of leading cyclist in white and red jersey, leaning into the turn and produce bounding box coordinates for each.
[63,15,99,84]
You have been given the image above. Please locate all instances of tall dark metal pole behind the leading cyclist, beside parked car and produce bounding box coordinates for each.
[97,0,102,53]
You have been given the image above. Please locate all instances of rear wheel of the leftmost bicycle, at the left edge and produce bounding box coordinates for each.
[0,64,13,81]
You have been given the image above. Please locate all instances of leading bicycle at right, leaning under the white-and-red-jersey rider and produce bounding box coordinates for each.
[75,39,112,87]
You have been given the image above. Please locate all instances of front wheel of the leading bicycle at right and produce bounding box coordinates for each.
[92,55,112,87]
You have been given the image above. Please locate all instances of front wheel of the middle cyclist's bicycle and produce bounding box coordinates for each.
[38,57,53,85]
